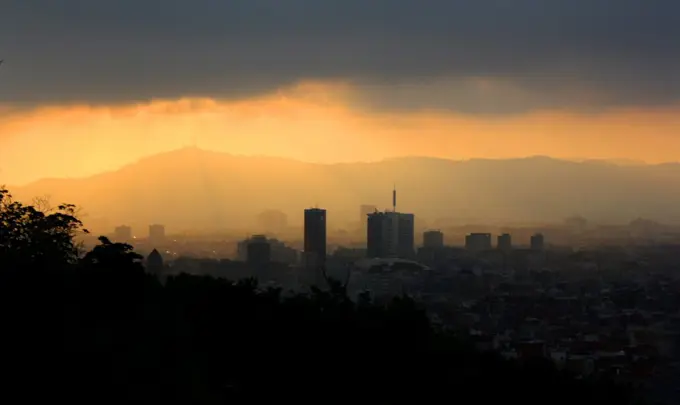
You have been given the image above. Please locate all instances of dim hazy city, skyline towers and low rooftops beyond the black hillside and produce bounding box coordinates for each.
[103,185,680,390]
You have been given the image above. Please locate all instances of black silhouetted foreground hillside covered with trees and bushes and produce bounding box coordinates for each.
[0,189,630,405]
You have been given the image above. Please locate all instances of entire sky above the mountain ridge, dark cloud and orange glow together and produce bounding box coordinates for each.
[0,0,680,184]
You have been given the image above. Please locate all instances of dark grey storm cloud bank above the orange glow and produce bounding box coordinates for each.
[0,0,680,112]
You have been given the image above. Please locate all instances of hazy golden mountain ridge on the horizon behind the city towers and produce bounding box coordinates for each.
[11,148,680,228]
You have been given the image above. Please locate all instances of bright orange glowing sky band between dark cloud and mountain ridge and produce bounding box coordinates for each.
[0,83,680,184]
